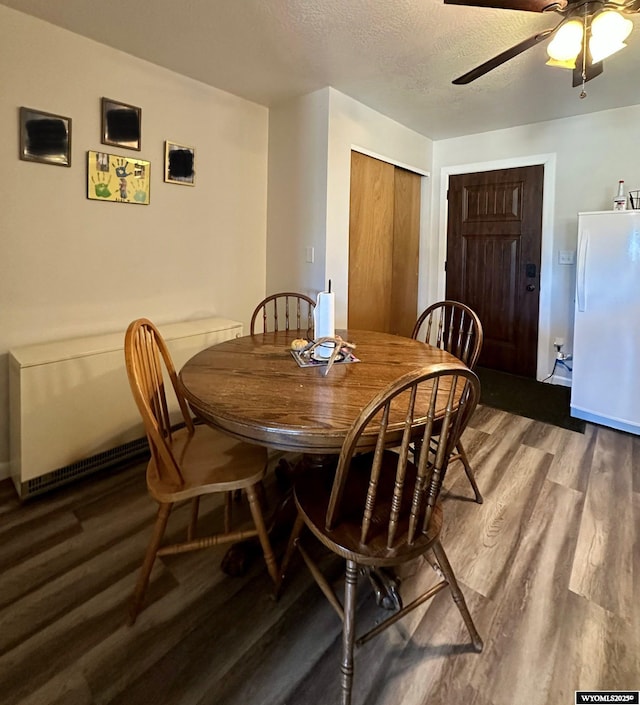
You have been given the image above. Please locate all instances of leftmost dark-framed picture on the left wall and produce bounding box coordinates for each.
[20,107,71,166]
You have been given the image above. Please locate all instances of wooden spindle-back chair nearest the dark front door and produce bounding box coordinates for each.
[411,300,483,504]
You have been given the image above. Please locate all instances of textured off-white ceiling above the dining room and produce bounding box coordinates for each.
[0,0,640,139]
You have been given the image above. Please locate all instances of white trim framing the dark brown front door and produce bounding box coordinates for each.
[438,152,556,381]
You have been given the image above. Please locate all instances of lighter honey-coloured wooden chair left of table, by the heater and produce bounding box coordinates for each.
[124,318,279,624]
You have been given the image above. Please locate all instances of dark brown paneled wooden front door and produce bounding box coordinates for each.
[446,165,544,377]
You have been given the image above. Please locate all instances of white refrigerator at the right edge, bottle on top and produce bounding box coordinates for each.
[571,210,640,434]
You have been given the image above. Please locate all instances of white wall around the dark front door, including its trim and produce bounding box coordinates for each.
[428,106,640,381]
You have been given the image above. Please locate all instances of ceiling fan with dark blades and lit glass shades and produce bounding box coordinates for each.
[444,0,640,92]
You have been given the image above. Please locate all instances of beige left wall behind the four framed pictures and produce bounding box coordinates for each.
[0,6,268,476]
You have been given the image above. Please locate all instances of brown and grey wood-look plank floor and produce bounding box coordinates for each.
[0,407,640,705]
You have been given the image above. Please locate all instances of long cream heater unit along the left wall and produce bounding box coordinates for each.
[9,317,242,499]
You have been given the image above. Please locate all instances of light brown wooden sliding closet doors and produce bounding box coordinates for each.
[348,152,421,336]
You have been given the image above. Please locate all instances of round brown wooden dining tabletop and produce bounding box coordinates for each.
[180,330,466,455]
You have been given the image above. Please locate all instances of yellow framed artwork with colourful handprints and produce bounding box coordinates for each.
[87,151,151,206]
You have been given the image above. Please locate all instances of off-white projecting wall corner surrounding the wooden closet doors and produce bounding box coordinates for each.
[267,88,432,327]
